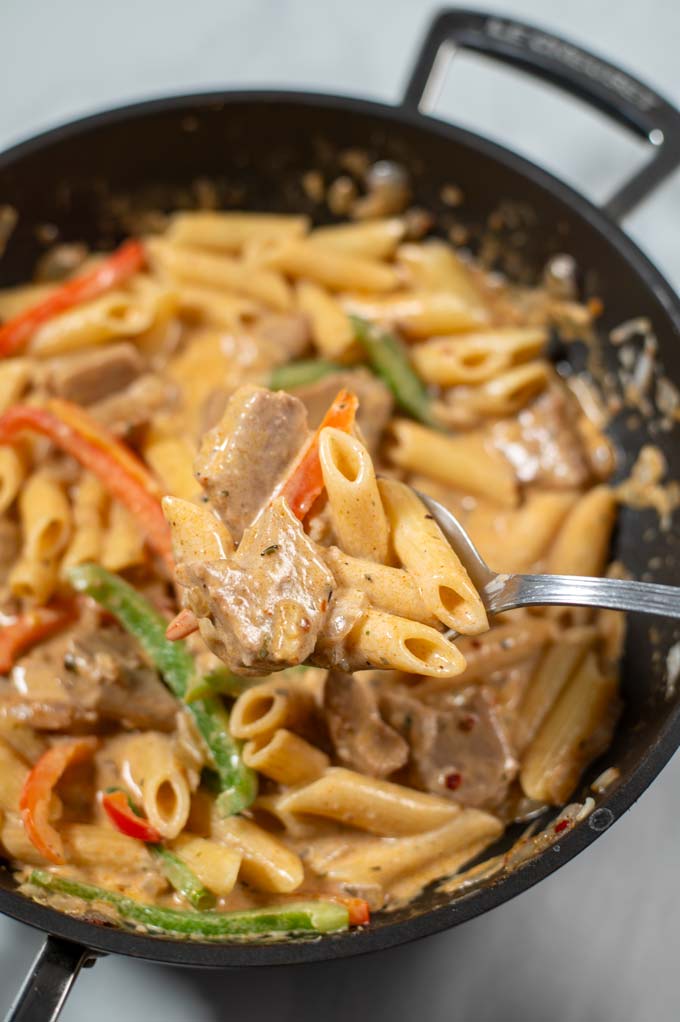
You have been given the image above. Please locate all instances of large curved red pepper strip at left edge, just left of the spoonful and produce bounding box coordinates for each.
[0,400,174,570]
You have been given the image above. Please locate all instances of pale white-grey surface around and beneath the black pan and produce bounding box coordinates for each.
[0,0,680,1022]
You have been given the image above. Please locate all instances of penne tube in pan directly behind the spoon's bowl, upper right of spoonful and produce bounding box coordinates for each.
[390,419,518,507]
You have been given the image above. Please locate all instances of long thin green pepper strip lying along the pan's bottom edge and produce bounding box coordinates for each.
[29,870,349,937]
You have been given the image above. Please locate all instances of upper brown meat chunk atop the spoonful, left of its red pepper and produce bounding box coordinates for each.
[195,386,308,542]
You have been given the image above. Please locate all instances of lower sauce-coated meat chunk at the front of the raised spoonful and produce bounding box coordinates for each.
[177,499,334,676]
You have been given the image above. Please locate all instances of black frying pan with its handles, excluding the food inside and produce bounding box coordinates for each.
[0,10,680,1022]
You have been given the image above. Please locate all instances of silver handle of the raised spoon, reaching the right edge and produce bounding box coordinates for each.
[483,574,680,618]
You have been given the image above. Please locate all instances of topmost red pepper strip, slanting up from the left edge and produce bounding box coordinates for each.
[0,241,145,358]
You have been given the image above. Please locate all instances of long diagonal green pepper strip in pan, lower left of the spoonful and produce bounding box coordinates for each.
[67,564,258,816]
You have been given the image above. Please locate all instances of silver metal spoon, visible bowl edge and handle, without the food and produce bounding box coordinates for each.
[418,493,680,618]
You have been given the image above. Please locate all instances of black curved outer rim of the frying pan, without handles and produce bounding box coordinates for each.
[0,89,680,969]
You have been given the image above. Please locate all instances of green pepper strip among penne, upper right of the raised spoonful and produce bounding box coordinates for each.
[350,316,436,426]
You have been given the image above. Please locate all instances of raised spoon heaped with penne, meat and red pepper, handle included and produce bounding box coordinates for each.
[163,385,680,678]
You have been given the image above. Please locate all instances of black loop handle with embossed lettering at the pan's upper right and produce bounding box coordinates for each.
[403,8,680,220]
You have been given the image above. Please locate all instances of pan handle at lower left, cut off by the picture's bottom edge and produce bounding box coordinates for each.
[5,936,96,1022]
